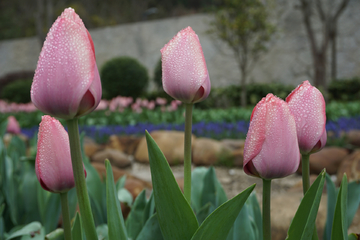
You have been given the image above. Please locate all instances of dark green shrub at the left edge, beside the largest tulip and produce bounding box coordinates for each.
[1,79,32,103]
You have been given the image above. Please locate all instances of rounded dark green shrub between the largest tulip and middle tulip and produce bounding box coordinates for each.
[100,57,149,99]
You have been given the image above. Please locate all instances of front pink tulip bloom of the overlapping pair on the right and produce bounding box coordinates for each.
[243,94,300,179]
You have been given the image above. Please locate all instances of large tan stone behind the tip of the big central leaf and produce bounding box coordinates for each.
[134,130,195,165]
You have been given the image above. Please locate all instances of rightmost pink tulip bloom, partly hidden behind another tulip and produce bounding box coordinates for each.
[286,81,327,154]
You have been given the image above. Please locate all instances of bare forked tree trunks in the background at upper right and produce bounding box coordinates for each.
[299,0,350,89]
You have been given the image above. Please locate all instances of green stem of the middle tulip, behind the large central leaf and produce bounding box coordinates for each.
[184,103,194,205]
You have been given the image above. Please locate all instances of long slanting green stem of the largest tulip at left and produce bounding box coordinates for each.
[66,118,98,240]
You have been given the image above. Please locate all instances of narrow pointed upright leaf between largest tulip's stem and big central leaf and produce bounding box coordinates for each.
[105,159,128,240]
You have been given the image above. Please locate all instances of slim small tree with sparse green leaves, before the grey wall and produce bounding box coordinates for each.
[209,0,275,107]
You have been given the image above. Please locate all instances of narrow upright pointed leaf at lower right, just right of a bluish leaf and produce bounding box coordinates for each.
[331,173,348,240]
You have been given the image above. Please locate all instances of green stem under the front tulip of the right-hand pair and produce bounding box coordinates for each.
[263,179,271,240]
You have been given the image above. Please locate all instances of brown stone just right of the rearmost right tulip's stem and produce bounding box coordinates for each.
[298,147,348,175]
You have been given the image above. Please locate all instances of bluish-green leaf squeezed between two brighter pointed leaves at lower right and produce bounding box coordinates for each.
[323,173,338,240]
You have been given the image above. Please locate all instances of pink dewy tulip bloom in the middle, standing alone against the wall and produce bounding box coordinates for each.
[161,27,211,103]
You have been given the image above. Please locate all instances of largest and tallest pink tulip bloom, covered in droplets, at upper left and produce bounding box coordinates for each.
[31,8,101,119]
